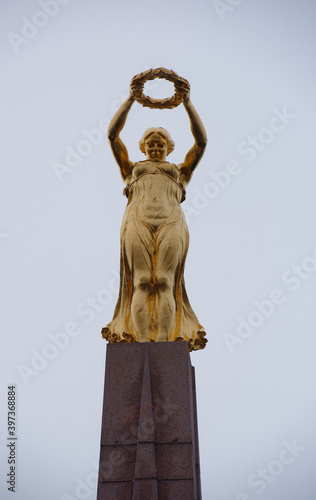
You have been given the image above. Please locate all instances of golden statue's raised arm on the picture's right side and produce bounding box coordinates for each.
[179,87,207,183]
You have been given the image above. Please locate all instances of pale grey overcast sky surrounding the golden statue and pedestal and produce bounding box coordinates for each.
[0,0,316,500]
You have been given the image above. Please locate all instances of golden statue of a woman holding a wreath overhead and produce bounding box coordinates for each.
[102,68,207,351]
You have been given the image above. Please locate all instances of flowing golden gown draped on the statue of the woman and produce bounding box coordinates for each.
[102,160,207,351]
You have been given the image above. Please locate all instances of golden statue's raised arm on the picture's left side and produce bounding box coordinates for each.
[108,92,134,181]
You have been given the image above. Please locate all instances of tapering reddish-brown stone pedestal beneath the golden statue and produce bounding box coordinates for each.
[97,341,201,500]
